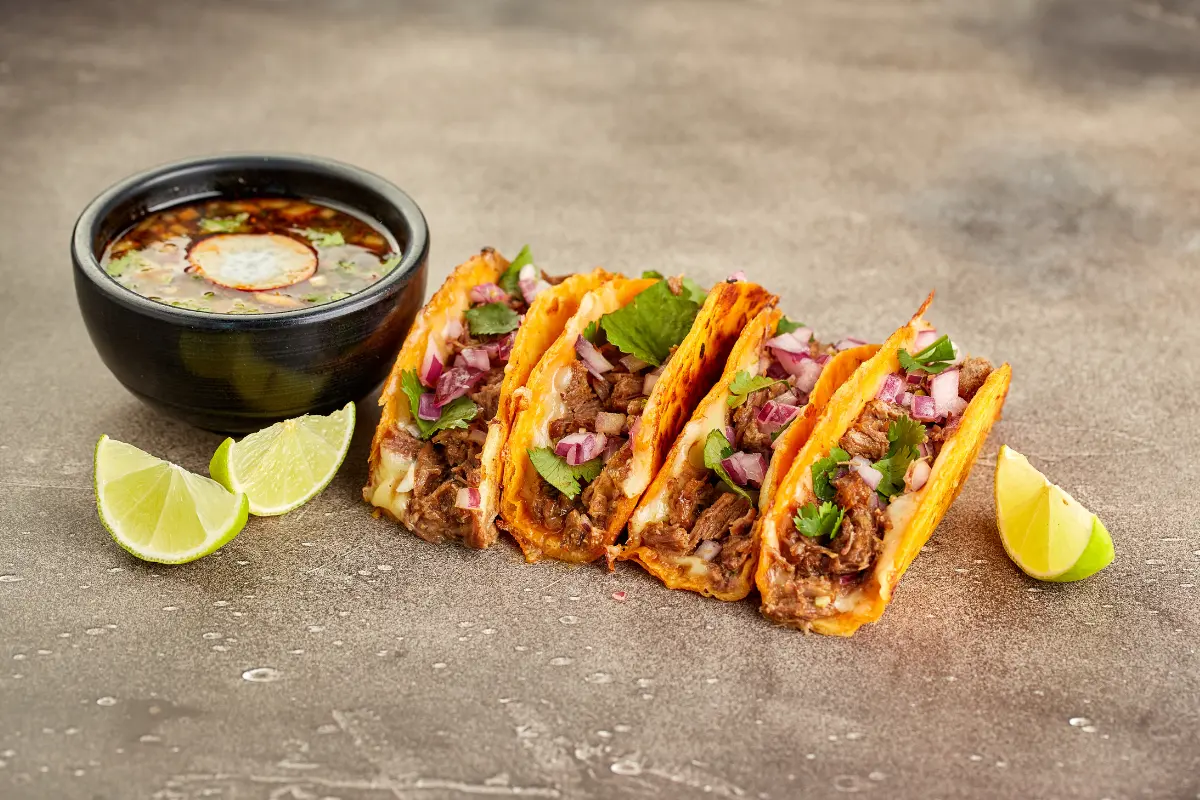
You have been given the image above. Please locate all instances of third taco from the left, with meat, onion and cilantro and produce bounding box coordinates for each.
[619,308,878,600]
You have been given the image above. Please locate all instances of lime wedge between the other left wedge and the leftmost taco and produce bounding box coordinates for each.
[209,403,354,517]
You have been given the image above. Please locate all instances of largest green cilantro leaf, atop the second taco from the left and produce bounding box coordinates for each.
[600,281,700,367]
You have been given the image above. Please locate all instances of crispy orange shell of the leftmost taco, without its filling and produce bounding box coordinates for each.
[362,247,611,548]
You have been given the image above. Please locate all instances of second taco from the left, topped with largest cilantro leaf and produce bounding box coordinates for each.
[500,277,774,561]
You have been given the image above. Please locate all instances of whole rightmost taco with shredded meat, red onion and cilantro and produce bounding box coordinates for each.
[755,294,1012,636]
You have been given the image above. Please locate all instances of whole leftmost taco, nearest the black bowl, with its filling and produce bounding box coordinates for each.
[362,247,612,548]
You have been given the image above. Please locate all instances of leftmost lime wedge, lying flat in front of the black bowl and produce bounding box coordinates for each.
[95,435,248,564]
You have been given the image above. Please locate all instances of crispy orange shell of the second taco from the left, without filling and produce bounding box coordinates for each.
[500,278,774,561]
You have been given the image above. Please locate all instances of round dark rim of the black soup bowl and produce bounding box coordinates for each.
[71,152,430,330]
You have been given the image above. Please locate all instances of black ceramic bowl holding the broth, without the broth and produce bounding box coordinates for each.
[71,155,430,433]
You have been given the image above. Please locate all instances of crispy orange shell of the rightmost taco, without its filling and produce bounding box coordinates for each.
[755,294,1012,636]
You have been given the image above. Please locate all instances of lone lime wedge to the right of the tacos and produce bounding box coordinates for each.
[996,445,1114,582]
